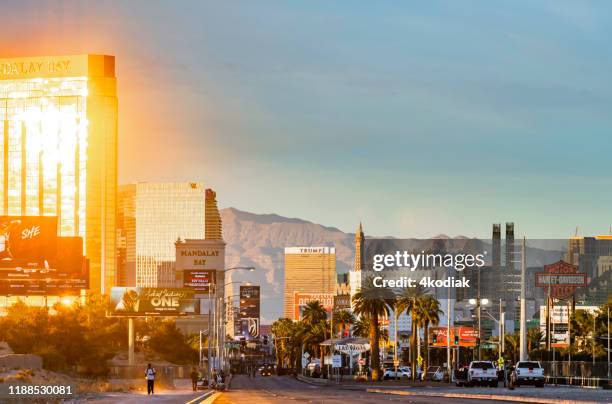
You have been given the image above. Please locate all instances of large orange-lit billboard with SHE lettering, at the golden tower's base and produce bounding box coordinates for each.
[0,216,89,296]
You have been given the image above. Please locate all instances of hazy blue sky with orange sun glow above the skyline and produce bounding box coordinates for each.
[0,0,612,237]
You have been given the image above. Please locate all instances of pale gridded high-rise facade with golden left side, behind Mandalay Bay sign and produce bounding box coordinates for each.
[117,182,205,287]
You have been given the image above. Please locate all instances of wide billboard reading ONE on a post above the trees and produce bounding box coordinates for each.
[109,287,197,317]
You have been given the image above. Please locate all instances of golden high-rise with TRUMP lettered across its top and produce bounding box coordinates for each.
[284,247,336,320]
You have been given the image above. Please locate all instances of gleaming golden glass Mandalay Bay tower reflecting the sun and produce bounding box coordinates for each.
[0,55,117,293]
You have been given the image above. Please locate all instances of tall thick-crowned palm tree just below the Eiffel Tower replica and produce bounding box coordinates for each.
[353,279,389,381]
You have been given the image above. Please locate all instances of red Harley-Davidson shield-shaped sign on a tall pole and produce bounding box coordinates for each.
[536,261,587,299]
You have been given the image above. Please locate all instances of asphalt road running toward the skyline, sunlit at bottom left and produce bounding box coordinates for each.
[215,375,510,404]
